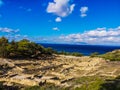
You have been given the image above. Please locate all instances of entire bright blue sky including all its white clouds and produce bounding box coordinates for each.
[0,0,120,45]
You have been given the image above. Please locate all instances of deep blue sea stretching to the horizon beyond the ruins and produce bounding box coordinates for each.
[41,44,120,55]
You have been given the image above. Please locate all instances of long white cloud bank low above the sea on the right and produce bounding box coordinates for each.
[59,27,120,44]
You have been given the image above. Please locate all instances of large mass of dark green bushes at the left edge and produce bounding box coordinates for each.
[0,37,55,58]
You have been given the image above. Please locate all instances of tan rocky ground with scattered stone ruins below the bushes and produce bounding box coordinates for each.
[0,55,120,87]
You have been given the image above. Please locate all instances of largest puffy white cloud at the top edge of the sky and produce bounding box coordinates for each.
[47,0,75,17]
